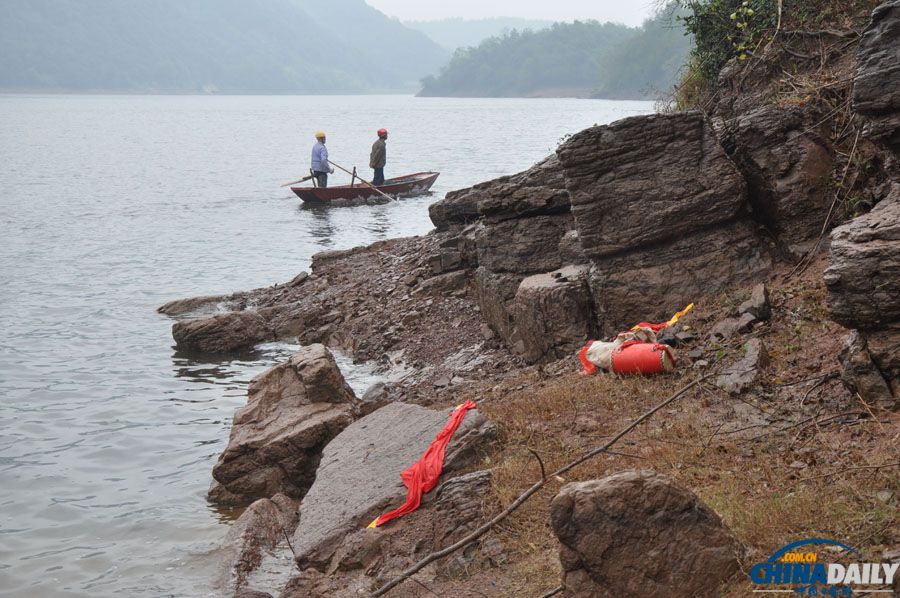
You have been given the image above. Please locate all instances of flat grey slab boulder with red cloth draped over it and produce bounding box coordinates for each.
[292,403,496,570]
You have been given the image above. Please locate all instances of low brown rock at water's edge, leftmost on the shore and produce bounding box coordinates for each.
[172,310,275,353]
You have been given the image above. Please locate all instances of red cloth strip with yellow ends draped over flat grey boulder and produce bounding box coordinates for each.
[369,401,476,528]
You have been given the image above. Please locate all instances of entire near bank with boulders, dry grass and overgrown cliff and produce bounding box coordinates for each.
[160,0,900,598]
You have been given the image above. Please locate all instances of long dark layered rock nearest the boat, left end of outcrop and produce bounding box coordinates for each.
[428,154,569,231]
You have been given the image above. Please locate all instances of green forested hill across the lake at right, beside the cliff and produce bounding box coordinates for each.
[419,5,690,99]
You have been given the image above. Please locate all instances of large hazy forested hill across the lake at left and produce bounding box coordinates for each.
[0,0,449,93]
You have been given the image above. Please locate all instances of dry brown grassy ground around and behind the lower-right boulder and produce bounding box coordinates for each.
[442,264,900,596]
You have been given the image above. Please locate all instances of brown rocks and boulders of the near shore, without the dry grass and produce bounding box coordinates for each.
[159,1,900,597]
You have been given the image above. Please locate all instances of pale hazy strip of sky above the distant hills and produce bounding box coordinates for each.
[366,0,657,25]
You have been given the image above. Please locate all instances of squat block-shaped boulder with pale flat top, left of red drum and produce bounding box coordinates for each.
[512,265,595,363]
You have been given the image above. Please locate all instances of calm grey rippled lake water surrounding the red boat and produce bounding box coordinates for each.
[0,95,652,597]
